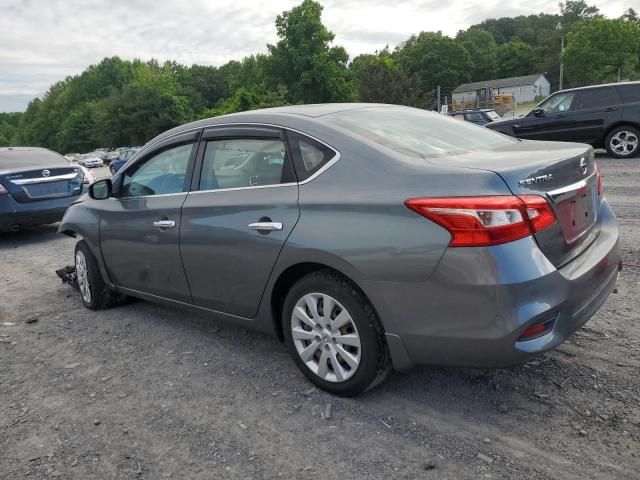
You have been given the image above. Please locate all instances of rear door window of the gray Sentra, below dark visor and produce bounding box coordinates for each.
[199,138,292,190]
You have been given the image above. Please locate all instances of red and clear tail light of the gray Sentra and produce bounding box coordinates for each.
[405,195,556,247]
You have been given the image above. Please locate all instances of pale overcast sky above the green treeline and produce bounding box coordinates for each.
[0,0,639,112]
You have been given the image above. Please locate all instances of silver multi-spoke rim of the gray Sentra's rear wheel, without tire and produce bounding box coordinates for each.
[291,293,362,382]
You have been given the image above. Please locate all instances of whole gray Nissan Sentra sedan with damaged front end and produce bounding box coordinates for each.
[60,104,620,395]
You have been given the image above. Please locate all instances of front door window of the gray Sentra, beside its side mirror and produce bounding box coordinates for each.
[120,143,193,197]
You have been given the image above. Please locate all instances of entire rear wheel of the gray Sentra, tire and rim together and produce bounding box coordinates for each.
[282,270,391,396]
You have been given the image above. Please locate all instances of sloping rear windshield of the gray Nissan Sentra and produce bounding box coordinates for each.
[325,106,517,157]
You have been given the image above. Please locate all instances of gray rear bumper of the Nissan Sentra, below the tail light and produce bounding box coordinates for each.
[363,197,620,369]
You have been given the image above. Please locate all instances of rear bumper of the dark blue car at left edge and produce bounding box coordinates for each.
[0,195,79,232]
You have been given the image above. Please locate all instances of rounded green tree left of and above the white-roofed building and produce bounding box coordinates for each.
[396,32,472,94]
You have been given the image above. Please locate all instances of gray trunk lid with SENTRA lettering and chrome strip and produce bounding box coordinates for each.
[430,141,600,267]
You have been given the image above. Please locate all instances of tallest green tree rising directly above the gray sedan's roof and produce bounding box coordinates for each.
[267,0,355,103]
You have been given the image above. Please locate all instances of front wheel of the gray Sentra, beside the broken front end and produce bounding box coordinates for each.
[74,240,123,310]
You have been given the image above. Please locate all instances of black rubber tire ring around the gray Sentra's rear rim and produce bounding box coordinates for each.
[282,272,383,396]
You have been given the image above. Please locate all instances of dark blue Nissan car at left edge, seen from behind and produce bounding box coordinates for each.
[0,147,84,232]
